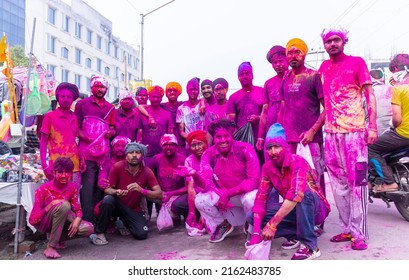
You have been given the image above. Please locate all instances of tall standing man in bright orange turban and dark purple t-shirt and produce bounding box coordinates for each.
[279,38,325,194]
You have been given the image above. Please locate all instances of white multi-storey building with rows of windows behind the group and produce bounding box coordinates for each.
[25,0,140,100]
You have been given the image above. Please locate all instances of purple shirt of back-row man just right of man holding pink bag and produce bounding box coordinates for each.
[114,108,140,142]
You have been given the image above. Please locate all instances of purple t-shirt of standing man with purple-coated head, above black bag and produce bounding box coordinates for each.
[226,86,267,139]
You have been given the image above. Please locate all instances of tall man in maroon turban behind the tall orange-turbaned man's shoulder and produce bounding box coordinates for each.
[256,45,288,151]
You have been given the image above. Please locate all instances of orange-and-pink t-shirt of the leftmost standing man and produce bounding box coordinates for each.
[40,108,80,172]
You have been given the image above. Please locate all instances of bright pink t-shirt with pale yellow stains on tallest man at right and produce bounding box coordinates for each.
[318,55,372,133]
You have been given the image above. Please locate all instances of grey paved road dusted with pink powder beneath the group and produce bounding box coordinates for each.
[7,185,409,260]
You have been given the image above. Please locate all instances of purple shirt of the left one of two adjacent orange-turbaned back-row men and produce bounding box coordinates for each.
[139,106,173,157]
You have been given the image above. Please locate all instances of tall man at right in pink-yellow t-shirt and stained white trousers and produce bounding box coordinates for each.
[318,28,378,250]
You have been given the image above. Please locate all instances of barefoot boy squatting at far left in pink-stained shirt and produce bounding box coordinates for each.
[29,157,94,259]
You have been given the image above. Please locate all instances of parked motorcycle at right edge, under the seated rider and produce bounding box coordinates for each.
[368,148,409,222]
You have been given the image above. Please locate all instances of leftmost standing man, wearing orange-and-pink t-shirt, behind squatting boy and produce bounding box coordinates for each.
[40,83,85,190]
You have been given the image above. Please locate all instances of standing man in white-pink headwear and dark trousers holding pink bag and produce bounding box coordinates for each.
[74,76,115,223]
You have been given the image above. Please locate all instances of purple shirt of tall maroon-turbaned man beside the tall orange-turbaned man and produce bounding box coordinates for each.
[263,76,283,131]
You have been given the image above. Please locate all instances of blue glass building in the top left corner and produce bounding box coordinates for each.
[0,0,26,46]
